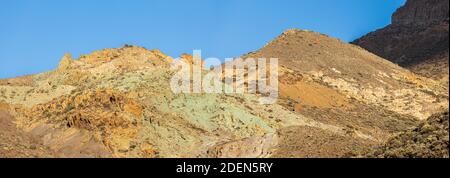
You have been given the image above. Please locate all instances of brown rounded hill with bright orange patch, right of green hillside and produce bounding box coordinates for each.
[243,29,448,157]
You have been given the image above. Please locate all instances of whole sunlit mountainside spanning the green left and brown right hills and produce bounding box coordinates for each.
[0,30,448,158]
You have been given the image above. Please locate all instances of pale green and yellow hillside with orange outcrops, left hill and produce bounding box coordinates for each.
[0,46,366,157]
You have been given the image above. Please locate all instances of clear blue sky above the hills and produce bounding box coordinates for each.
[0,0,405,78]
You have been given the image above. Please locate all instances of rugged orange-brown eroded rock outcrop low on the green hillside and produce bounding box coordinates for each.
[17,90,143,157]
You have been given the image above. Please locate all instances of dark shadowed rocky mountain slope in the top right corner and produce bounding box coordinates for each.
[353,0,449,85]
